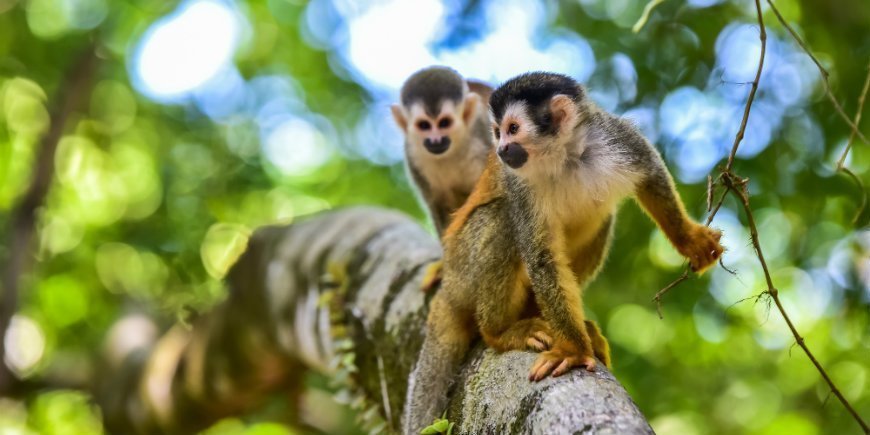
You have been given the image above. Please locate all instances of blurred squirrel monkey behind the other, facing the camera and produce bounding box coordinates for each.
[391,66,494,237]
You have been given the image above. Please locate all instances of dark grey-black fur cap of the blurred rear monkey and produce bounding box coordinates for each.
[402,66,465,117]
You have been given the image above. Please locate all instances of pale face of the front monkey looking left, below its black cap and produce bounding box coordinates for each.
[493,95,577,177]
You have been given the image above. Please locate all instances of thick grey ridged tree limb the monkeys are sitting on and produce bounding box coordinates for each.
[98,208,652,434]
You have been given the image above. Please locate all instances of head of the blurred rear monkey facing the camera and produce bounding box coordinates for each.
[392,66,480,156]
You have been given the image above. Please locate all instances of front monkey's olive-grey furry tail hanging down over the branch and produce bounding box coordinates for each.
[402,293,475,435]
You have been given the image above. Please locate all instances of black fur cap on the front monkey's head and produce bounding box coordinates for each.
[489,72,585,134]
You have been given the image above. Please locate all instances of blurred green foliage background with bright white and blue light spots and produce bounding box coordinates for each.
[0,0,870,435]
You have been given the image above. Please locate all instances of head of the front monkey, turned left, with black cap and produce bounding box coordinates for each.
[490,72,588,176]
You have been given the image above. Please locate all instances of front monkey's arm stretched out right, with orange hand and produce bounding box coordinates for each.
[620,122,723,272]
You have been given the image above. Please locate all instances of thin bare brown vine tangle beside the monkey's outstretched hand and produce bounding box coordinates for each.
[653,0,870,434]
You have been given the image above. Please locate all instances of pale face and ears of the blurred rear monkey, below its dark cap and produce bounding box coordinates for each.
[393,93,480,157]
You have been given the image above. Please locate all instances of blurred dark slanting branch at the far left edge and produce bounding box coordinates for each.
[0,45,98,395]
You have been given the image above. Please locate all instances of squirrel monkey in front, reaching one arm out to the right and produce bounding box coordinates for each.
[404,72,723,433]
